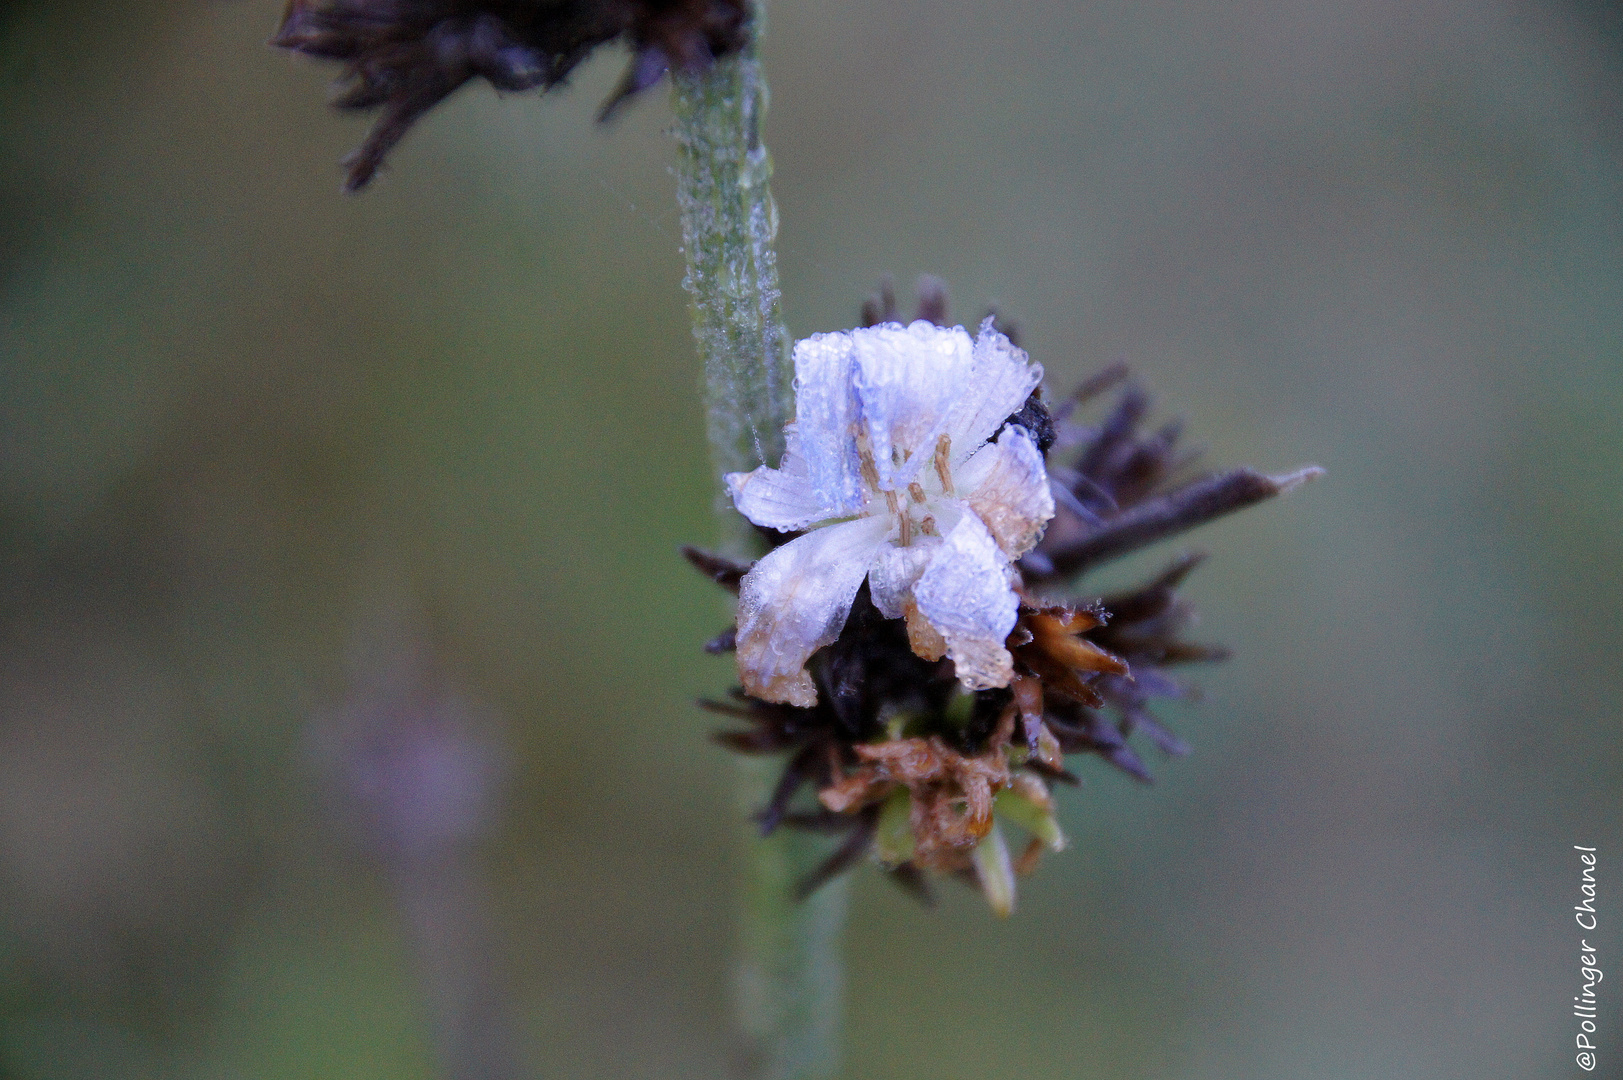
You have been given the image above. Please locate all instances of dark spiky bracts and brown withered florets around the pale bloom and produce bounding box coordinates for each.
[685,278,1318,911]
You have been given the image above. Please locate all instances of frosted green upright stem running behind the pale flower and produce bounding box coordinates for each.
[674,5,847,1080]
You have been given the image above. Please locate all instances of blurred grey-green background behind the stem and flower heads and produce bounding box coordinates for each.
[0,0,1623,1080]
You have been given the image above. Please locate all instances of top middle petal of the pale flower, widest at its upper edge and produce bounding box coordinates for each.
[850,318,973,490]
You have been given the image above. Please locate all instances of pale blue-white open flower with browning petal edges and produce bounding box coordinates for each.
[727,318,1053,705]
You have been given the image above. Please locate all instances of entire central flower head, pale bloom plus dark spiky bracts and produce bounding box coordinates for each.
[687,278,1321,914]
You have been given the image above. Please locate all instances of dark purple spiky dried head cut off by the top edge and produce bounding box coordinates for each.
[271,0,750,192]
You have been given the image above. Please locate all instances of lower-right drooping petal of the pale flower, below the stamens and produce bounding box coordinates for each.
[914,513,1019,690]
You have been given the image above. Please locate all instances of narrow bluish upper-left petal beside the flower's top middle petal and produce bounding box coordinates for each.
[784,330,862,516]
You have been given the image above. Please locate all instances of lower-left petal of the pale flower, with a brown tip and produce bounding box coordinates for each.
[738,518,891,706]
